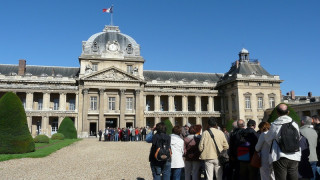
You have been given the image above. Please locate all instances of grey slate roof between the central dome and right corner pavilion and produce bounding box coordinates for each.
[143,70,223,83]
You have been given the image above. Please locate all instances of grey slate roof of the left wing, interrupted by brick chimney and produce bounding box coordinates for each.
[0,64,80,77]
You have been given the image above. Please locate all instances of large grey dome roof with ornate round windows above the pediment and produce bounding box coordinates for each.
[81,26,140,58]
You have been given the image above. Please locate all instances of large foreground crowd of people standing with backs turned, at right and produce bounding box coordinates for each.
[149,104,320,180]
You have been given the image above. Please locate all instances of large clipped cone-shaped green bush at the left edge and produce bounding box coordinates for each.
[0,92,35,154]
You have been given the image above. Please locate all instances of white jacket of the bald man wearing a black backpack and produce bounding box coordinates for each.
[264,115,301,164]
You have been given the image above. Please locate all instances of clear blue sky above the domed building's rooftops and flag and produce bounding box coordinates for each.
[0,0,320,96]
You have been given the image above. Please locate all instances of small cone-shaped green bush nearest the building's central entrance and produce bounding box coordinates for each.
[58,117,77,139]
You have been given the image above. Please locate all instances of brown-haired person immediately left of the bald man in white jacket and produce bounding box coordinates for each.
[252,122,275,180]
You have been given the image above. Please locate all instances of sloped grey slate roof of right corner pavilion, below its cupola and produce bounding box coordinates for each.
[223,61,270,79]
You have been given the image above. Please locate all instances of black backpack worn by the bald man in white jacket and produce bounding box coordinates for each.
[276,120,300,153]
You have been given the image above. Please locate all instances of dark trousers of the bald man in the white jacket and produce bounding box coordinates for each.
[272,157,299,180]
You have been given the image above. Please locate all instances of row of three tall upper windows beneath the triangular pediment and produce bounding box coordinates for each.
[90,96,133,111]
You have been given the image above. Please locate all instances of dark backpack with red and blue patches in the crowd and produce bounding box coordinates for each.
[237,132,251,162]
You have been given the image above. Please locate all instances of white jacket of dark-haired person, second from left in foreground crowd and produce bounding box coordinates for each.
[171,134,184,168]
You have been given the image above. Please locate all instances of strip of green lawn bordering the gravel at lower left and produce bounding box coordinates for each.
[0,139,81,162]
